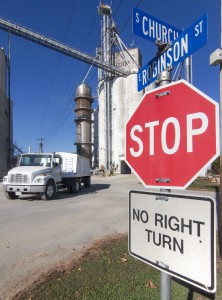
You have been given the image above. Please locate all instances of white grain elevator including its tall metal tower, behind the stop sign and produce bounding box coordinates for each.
[94,5,143,173]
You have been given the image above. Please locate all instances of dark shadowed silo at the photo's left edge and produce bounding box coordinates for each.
[0,48,12,177]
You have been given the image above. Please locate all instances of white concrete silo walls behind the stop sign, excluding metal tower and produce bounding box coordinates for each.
[98,48,143,173]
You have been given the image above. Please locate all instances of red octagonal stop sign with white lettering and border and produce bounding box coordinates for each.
[126,80,219,189]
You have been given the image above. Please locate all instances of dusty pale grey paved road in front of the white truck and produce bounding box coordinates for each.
[0,175,218,300]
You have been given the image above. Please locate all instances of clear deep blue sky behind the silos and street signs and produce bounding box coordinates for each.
[0,0,221,152]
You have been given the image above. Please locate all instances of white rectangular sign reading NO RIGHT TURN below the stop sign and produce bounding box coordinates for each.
[129,191,216,293]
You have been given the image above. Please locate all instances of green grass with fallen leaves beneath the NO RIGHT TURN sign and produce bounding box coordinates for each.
[16,234,222,300]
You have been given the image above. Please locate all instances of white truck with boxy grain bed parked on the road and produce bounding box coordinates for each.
[2,152,91,200]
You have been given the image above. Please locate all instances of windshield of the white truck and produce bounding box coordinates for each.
[19,154,52,167]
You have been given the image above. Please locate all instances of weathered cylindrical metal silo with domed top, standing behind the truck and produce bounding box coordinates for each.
[74,83,93,160]
